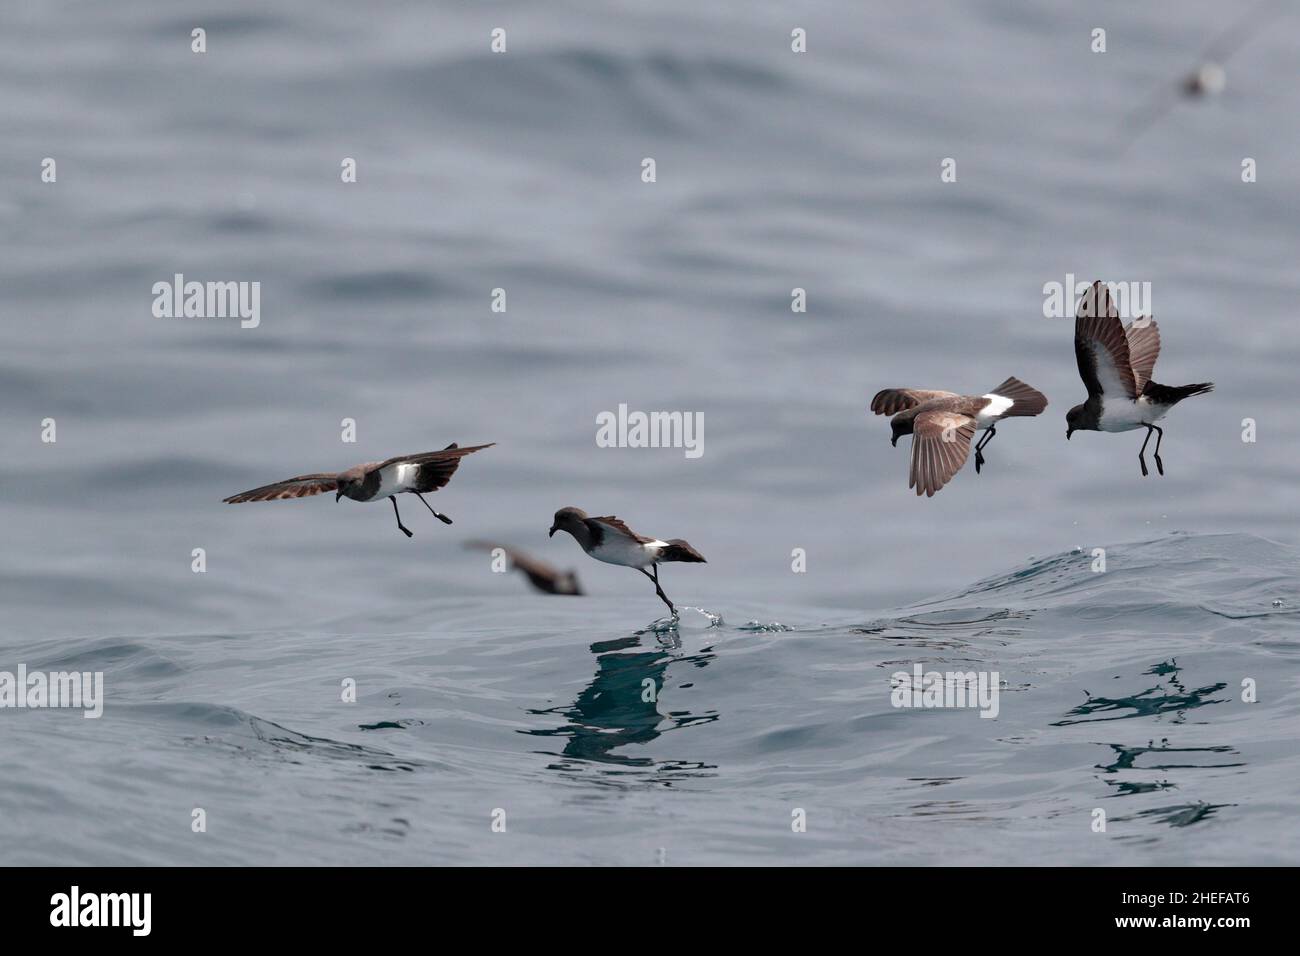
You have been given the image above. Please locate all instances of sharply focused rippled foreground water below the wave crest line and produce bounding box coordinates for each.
[3,533,1300,865]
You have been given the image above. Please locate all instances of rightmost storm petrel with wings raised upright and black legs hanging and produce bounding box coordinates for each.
[1065,282,1214,477]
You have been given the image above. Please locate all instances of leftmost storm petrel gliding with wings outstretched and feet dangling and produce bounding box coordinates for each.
[222,442,497,537]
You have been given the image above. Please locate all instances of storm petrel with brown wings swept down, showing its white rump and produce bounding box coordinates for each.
[871,378,1048,497]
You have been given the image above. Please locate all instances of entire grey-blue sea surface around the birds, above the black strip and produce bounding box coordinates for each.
[0,0,1300,865]
